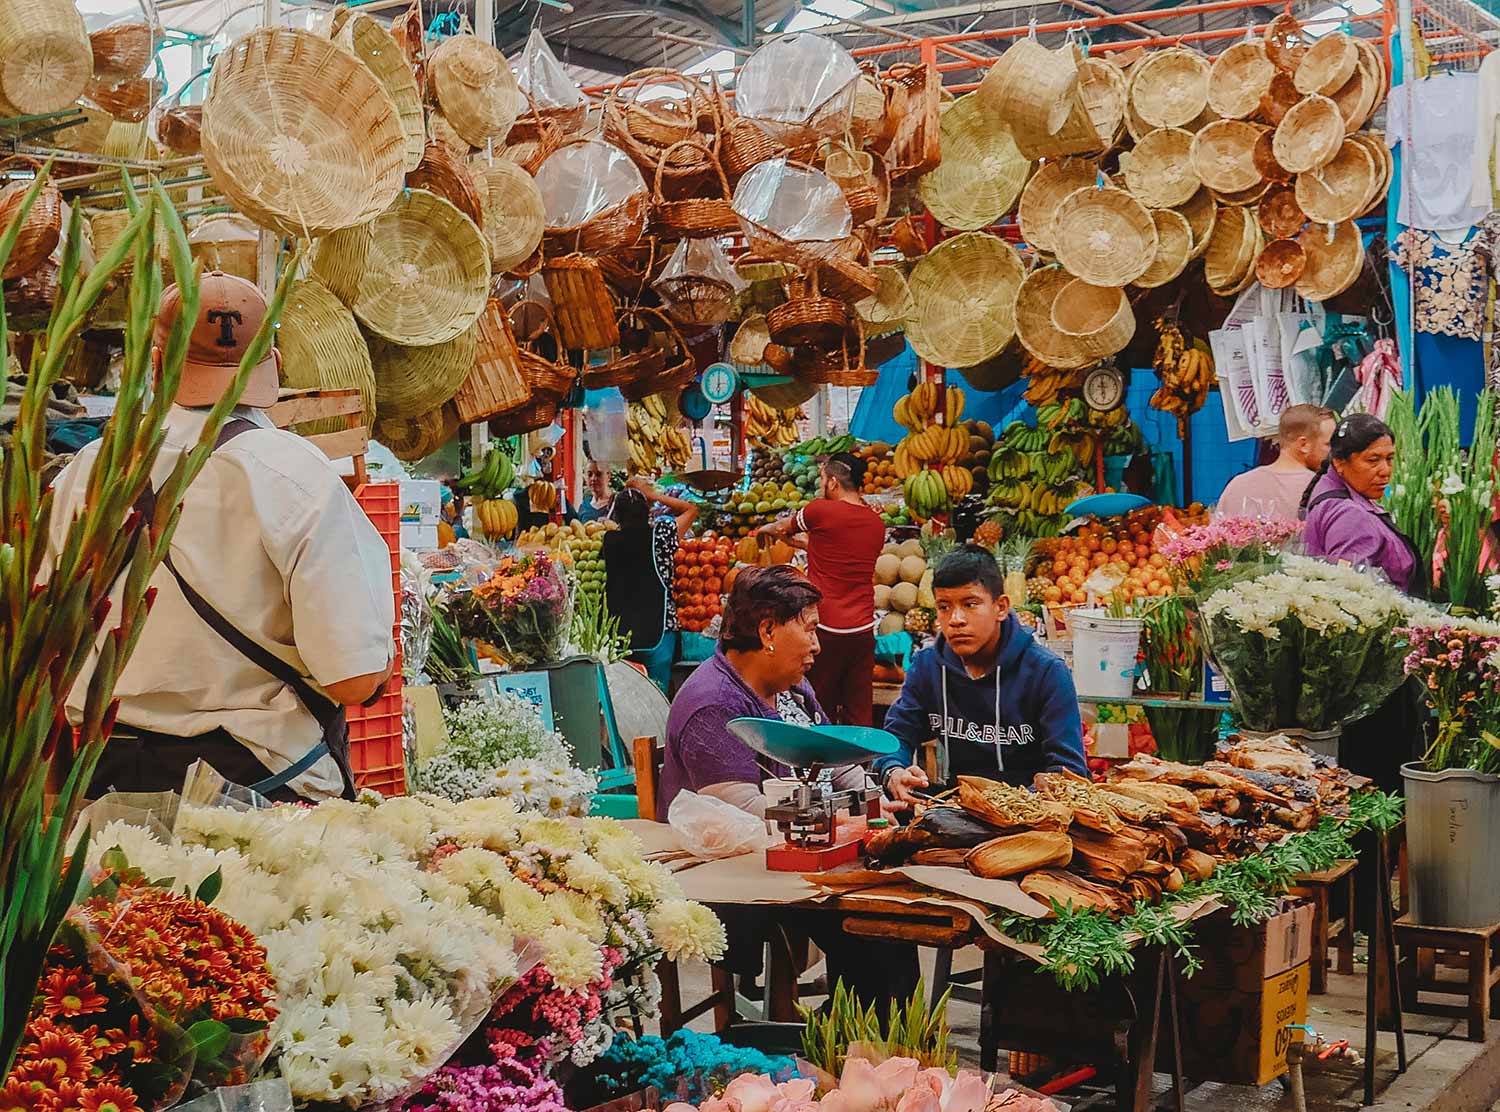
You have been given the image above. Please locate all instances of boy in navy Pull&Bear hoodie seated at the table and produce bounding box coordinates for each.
[875,545,1089,803]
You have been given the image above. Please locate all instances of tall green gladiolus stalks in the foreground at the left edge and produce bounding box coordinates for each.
[0,167,294,1076]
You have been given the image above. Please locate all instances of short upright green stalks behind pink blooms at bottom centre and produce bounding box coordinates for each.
[801,980,959,1077]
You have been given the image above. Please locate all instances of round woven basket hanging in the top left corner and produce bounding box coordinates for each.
[0,0,89,116]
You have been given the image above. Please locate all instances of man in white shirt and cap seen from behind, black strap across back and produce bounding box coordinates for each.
[51,273,395,800]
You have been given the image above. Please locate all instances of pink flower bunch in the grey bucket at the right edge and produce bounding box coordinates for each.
[1401,614,1500,773]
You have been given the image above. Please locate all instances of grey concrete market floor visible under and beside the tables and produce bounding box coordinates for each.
[681,948,1500,1112]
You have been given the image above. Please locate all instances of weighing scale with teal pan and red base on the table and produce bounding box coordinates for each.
[729,719,900,872]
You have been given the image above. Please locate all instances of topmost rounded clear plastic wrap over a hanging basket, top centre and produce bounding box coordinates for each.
[735,35,860,146]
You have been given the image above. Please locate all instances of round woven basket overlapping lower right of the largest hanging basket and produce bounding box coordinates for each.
[354,189,491,346]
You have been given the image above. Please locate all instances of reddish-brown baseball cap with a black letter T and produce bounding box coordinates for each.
[156,270,281,410]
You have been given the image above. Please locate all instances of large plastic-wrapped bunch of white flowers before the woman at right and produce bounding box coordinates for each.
[1202,557,1416,731]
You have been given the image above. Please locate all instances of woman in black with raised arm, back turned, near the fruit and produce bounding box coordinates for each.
[602,477,698,695]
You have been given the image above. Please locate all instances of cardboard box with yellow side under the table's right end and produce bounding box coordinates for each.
[1158,903,1313,1085]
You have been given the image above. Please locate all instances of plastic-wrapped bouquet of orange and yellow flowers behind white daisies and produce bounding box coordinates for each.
[450,551,573,668]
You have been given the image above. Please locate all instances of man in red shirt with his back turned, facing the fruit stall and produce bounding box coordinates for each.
[761,452,885,726]
